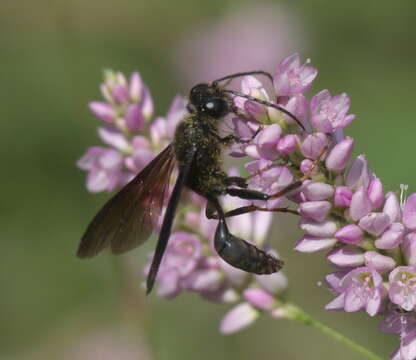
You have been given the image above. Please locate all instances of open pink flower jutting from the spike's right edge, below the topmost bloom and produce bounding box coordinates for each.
[310,90,355,133]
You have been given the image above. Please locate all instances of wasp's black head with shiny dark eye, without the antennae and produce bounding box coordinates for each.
[189,84,230,119]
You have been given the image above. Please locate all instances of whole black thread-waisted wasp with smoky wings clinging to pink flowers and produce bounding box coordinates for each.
[77,71,303,293]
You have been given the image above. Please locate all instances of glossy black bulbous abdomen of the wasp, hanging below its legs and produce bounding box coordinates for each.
[214,219,283,274]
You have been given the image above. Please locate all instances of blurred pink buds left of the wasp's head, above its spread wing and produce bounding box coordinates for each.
[77,71,186,192]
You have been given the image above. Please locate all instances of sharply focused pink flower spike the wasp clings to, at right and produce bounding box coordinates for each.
[232,54,416,359]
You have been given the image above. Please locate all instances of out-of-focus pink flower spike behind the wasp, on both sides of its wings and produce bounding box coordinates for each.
[78,72,287,333]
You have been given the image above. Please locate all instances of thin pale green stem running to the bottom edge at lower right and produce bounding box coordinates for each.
[283,303,383,360]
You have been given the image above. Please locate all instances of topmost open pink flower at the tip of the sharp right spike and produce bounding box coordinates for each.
[274,53,318,96]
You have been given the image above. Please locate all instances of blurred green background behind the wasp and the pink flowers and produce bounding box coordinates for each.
[0,0,416,360]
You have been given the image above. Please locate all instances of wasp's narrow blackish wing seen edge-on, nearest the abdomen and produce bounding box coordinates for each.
[146,147,196,295]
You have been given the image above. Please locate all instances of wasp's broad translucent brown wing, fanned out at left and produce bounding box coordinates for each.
[77,145,175,258]
